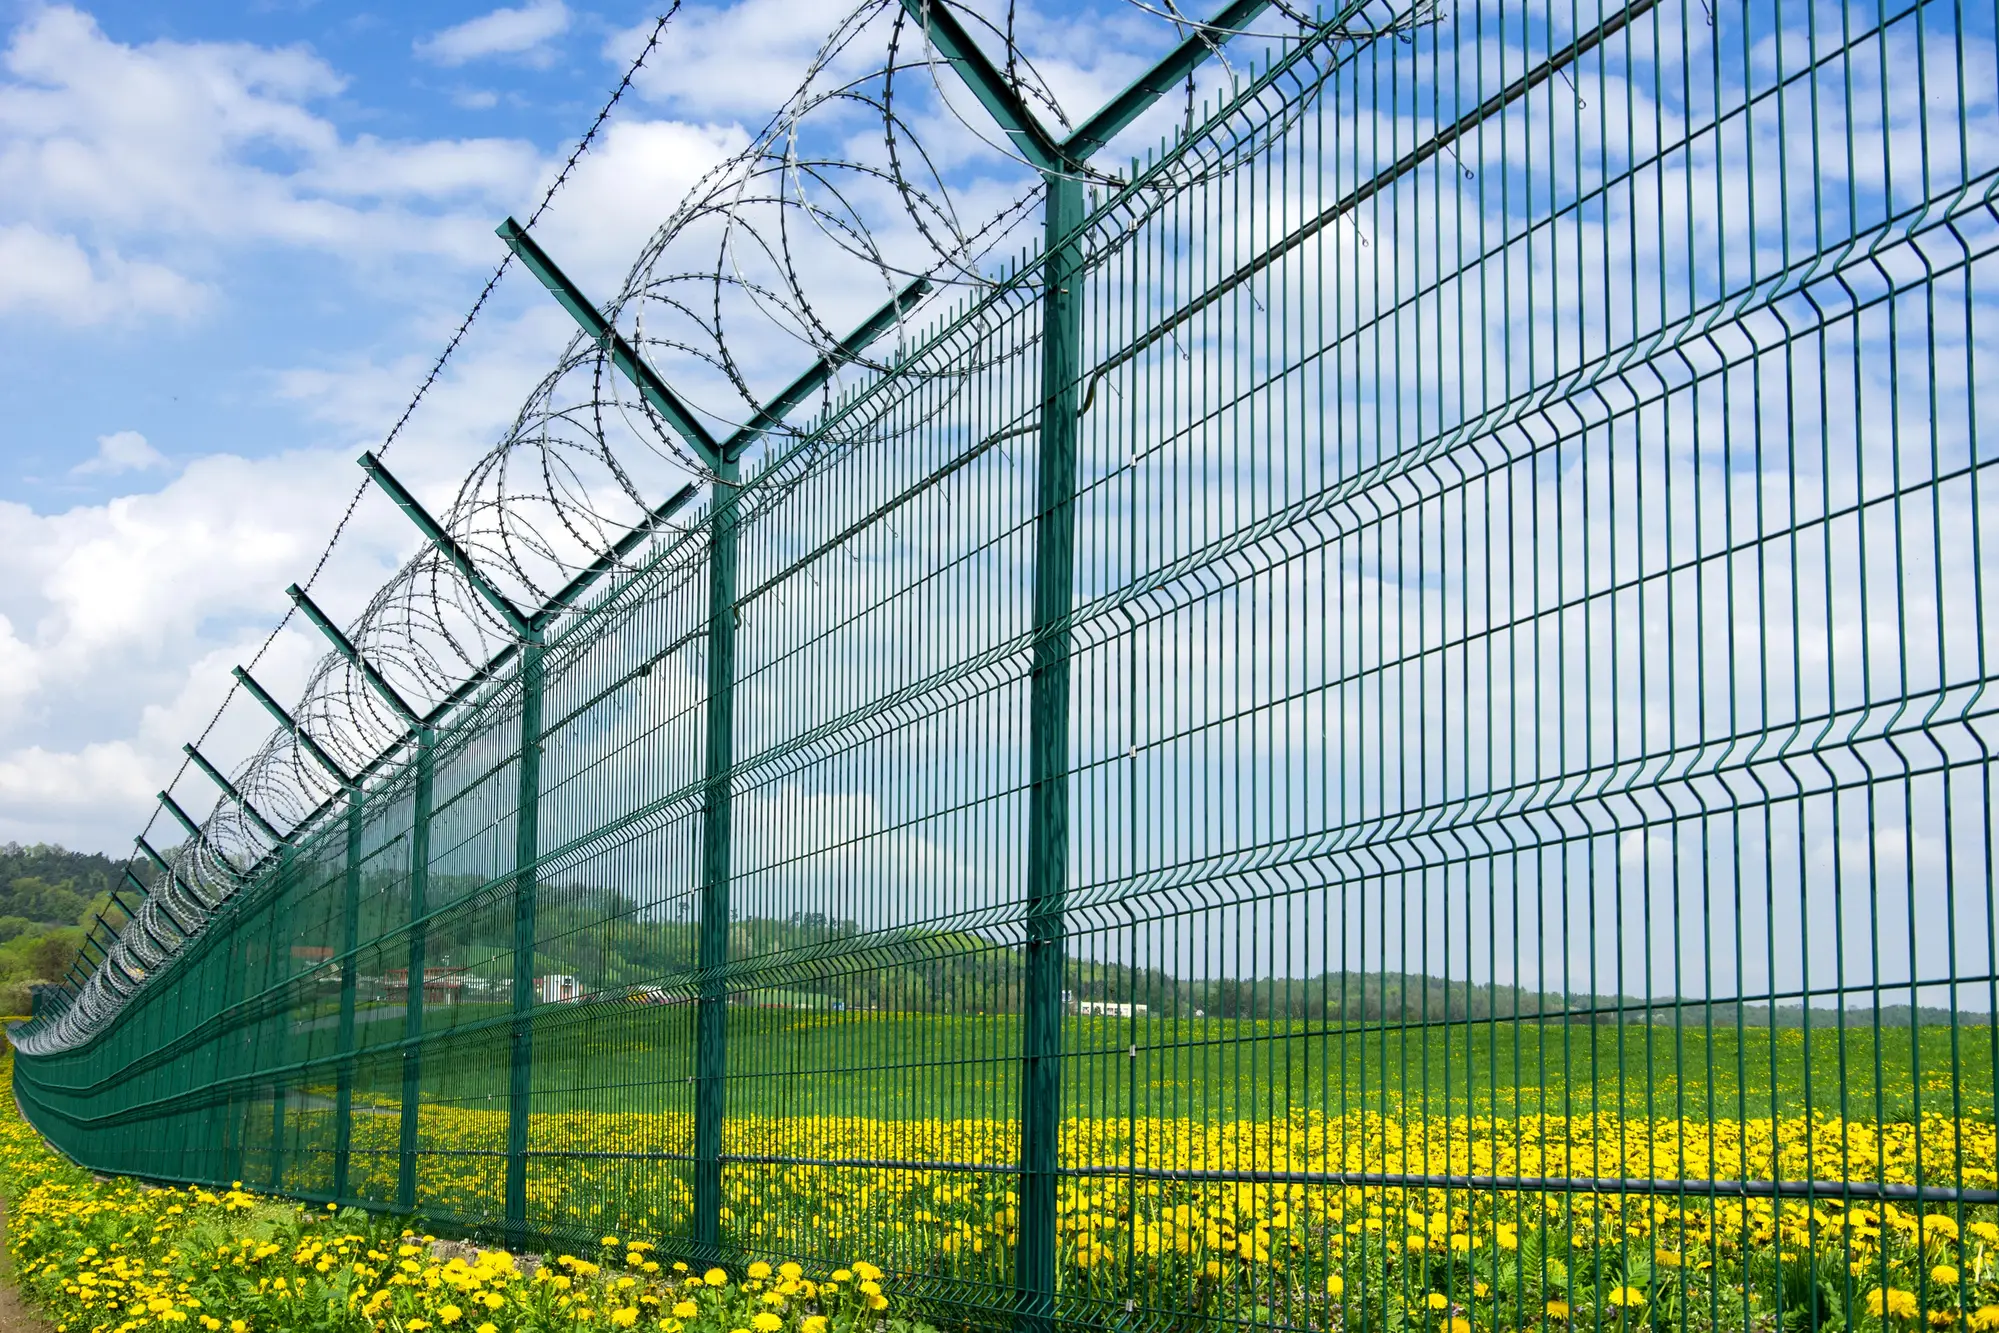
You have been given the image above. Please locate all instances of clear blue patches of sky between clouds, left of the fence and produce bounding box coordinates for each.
[0,4,646,503]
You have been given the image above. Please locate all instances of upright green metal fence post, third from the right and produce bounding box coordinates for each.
[506,632,544,1245]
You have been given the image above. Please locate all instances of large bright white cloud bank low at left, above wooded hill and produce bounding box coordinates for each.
[0,285,611,849]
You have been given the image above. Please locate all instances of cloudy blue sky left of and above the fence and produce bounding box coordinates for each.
[0,0,1215,849]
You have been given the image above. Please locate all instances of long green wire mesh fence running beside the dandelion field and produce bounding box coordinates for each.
[16,0,1999,1333]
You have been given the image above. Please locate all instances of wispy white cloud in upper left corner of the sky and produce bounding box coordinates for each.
[0,6,548,326]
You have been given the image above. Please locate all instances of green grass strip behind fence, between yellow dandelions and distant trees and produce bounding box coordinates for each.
[384,1007,1999,1121]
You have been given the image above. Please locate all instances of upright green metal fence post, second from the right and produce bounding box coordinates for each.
[694,462,736,1261]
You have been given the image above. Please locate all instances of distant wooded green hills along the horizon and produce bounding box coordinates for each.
[11,843,1991,1029]
